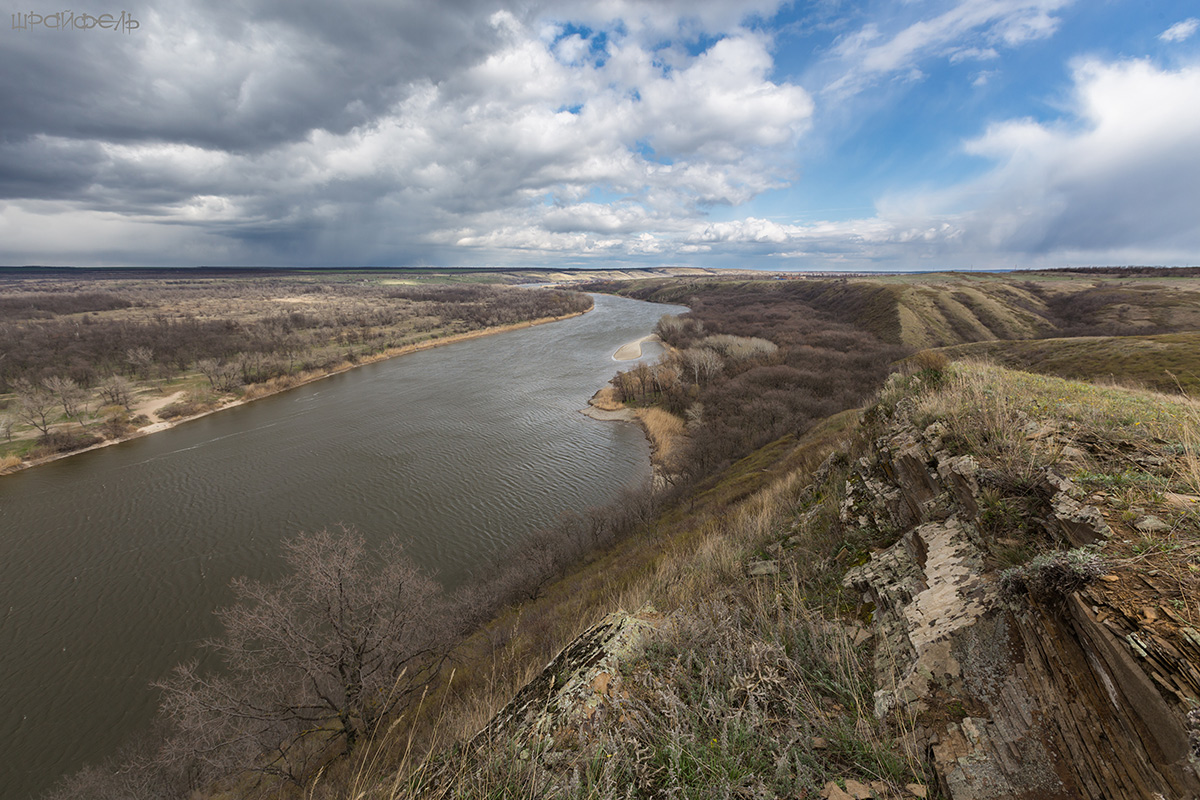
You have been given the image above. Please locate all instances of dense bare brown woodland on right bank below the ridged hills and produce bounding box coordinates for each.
[594,282,910,480]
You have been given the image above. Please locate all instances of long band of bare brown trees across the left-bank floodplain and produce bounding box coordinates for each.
[0,285,590,392]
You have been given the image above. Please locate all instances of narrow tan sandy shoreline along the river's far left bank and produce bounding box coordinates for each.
[0,303,590,475]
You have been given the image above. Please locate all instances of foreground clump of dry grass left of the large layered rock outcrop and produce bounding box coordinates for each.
[398,581,920,800]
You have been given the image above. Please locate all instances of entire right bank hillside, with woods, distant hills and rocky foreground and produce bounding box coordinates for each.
[46,275,1200,800]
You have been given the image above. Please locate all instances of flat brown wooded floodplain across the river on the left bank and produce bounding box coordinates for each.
[0,271,590,459]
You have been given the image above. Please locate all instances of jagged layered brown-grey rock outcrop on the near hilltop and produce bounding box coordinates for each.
[841,423,1200,800]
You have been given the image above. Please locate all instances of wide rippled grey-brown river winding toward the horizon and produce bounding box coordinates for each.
[0,295,682,800]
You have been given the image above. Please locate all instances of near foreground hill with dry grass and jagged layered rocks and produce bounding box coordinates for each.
[390,363,1200,800]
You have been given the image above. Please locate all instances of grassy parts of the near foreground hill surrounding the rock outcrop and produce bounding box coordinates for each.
[369,363,1200,798]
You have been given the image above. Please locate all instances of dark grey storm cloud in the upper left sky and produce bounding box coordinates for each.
[0,0,506,151]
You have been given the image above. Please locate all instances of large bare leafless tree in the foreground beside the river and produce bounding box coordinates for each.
[160,528,454,784]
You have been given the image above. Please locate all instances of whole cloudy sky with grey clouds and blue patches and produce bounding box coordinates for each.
[0,0,1200,270]
